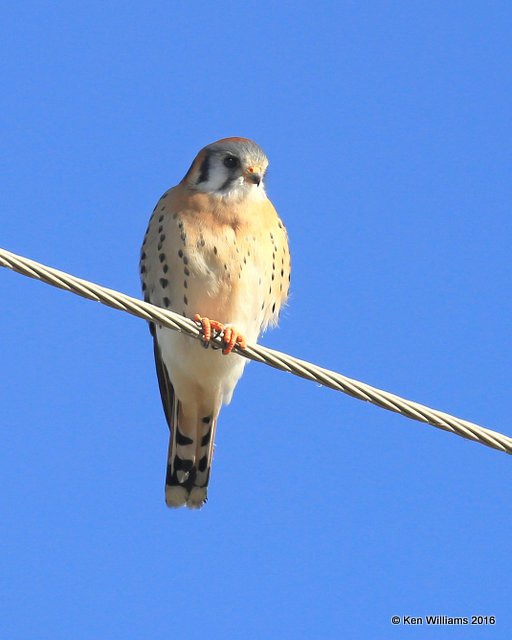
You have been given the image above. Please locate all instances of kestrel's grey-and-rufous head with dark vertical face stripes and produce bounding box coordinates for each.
[183,138,268,200]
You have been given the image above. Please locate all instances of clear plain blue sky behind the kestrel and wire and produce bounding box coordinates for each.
[0,0,512,640]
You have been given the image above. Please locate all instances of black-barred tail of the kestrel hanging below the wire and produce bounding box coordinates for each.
[165,397,217,509]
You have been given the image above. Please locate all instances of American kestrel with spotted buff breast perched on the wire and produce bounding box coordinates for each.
[140,138,290,508]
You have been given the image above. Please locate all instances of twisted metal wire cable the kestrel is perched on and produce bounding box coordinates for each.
[0,248,512,454]
